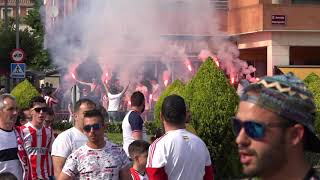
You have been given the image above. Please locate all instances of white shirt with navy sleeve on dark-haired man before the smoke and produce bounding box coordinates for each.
[122,110,147,157]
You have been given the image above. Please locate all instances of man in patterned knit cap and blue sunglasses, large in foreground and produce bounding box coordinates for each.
[232,73,320,180]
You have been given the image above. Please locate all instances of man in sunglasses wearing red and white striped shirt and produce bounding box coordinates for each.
[21,96,54,179]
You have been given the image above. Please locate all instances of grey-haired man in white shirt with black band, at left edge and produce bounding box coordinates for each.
[0,94,31,180]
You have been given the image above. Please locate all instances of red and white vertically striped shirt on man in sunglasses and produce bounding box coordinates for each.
[21,122,54,179]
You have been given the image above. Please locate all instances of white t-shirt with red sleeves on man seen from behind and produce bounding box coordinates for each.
[146,129,211,180]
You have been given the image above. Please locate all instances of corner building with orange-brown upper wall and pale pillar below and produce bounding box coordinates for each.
[227,0,320,78]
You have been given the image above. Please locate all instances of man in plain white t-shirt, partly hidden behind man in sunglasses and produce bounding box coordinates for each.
[51,99,96,178]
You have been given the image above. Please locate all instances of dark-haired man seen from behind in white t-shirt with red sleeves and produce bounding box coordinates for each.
[146,95,213,180]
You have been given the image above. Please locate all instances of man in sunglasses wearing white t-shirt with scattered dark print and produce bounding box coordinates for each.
[59,110,131,180]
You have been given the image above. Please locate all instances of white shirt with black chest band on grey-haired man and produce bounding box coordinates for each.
[0,129,23,179]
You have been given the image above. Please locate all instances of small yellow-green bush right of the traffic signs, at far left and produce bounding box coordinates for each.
[11,79,40,108]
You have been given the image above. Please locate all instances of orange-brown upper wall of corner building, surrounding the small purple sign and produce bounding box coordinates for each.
[228,0,320,35]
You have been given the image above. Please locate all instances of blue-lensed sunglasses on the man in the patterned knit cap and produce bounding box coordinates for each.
[231,117,291,139]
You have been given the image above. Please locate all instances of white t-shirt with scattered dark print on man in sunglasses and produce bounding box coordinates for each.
[62,141,130,180]
